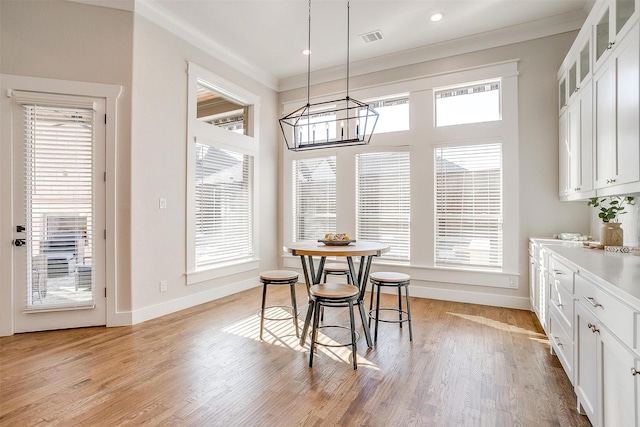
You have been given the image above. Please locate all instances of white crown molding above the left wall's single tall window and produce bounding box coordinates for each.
[134,0,278,90]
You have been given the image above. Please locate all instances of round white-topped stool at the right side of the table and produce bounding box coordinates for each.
[369,272,413,342]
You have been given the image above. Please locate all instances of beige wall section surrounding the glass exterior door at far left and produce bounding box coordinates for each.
[0,0,133,320]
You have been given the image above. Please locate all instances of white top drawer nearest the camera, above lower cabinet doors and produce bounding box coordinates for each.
[575,274,636,348]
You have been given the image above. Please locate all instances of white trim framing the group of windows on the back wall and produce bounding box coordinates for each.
[281,59,526,289]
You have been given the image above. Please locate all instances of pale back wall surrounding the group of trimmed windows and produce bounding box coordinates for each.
[279,32,590,308]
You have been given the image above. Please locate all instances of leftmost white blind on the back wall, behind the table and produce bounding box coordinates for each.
[292,156,337,242]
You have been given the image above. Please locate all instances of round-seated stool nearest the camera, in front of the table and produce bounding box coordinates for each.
[307,283,360,370]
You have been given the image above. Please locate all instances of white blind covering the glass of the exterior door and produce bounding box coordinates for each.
[20,104,94,310]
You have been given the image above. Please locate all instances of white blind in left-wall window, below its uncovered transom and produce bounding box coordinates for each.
[195,143,253,269]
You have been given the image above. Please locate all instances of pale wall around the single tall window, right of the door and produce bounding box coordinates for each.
[131,15,278,323]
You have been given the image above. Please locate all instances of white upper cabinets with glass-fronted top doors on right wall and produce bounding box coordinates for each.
[558,0,640,200]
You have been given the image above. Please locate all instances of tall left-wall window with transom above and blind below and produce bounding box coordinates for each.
[186,63,260,284]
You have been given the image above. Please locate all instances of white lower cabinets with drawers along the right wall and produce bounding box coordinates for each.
[530,245,640,427]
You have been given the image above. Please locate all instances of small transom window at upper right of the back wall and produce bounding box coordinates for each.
[435,81,500,127]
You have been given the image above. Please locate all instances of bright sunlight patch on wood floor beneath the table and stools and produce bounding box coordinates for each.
[222,307,378,369]
